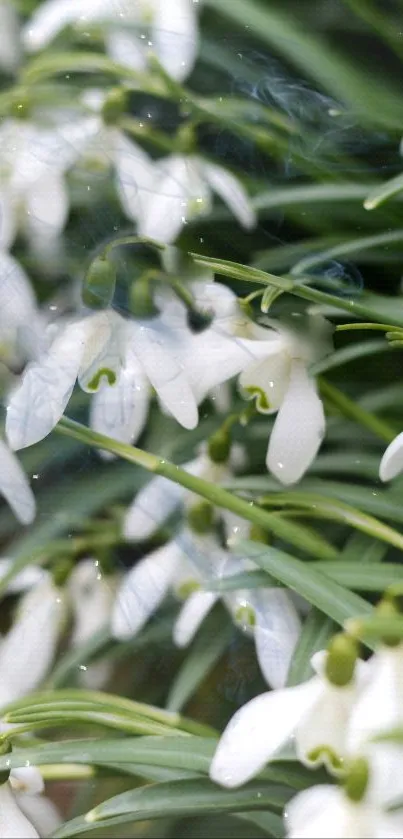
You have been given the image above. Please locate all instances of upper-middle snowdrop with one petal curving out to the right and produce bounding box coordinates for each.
[126,154,256,244]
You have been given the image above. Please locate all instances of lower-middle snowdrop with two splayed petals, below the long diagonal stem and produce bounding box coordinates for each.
[174,511,301,688]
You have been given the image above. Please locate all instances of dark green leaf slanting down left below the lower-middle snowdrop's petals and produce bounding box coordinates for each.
[167,610,233,711]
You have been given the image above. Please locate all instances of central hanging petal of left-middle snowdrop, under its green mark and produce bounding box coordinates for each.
[90,350,150,450]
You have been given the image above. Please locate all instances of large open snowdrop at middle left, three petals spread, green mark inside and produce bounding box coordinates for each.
[6,310,198,449]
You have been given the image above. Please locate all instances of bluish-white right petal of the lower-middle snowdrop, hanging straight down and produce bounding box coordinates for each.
[254,588,301,688]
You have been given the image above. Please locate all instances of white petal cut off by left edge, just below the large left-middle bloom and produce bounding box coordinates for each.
[0,440,36,524]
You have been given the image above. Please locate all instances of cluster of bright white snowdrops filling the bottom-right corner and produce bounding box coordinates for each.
[210,636,403,839]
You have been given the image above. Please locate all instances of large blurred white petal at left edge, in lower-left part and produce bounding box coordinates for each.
[0,576,65,707]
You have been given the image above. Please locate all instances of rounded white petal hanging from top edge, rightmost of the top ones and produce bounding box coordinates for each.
[152,0,198,81]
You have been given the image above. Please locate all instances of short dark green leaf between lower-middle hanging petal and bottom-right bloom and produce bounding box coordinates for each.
[287,608,337,687]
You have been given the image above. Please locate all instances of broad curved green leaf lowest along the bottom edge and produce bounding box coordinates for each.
[53,778,290,839]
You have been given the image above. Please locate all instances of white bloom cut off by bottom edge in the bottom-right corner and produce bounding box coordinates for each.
[285,784,403,839]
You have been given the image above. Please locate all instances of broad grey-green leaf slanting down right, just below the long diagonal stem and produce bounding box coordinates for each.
[237,540,372,626]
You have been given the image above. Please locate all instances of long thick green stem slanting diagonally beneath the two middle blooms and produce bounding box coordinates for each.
[56,417,337,559]
